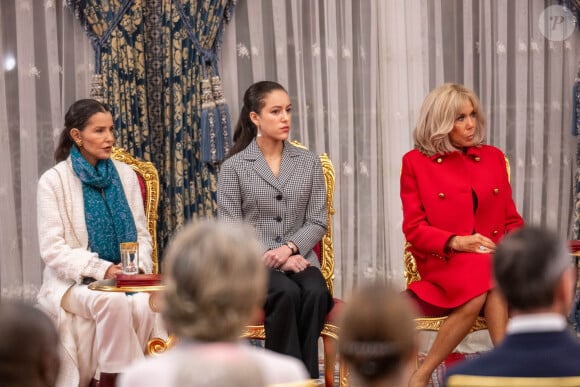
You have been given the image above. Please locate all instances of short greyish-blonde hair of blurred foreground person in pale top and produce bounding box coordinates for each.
[161,220,266,342]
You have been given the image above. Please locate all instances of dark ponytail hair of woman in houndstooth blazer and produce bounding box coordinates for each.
[228,81,286,157]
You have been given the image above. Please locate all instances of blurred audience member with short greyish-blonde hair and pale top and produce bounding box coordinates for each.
[120,220,308,387]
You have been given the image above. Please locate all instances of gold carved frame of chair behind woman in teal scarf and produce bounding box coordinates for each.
[111,146,159,273]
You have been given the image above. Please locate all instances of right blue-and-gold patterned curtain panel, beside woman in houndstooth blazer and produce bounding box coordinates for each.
[161,0,233,244]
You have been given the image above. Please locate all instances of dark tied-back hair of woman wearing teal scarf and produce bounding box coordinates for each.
[54,99,109,163]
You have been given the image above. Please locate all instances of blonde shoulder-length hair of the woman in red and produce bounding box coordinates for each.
[413,83,485,156]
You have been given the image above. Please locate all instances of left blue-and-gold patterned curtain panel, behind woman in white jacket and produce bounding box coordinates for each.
[68,0,151,160]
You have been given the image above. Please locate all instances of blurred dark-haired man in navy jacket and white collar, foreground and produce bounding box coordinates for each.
[447,227,580,386]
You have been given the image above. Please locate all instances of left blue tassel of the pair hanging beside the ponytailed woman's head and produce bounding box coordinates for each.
[201,79,220,163]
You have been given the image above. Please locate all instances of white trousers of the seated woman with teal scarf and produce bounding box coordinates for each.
[61,285,155,373]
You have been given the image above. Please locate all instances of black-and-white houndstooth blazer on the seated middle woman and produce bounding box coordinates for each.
[217,139,327,267]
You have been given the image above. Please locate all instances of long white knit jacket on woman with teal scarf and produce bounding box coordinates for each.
[37,157,152,386]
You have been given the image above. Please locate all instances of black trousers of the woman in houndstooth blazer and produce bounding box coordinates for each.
[264,266,334,379]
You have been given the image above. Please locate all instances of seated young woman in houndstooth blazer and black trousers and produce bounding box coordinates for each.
[217,81,333,378]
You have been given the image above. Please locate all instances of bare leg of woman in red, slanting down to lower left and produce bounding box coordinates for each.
[409,293,487,387]
